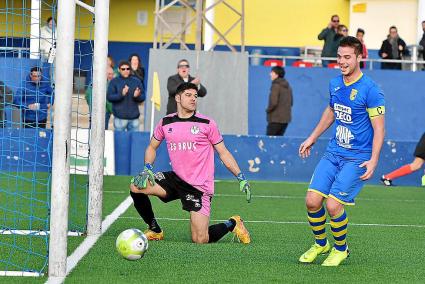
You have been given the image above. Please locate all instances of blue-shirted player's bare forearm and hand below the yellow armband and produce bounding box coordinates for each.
[360,115,385,180]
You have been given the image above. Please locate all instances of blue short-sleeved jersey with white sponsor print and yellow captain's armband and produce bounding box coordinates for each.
[327,73,385,160]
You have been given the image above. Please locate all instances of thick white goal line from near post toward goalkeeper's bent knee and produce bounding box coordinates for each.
[46,196,133,284]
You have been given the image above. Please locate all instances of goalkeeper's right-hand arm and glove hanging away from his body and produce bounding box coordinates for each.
[214,141,251,202]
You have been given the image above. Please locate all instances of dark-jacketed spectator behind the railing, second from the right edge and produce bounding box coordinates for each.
[379,26,409,70]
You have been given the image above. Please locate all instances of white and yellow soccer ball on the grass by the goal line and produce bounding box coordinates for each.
[115,229,148,260]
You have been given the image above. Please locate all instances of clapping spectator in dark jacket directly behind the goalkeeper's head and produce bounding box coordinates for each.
[167,59,207,114]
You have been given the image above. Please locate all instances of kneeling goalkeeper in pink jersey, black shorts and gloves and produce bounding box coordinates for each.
[130,83,251,244]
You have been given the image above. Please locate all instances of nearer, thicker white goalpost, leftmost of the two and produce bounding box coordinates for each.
[49,0,76,278]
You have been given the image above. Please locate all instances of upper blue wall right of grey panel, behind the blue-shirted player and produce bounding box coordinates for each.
[248,66,425,141]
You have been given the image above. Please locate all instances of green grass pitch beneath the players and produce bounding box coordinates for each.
[0,177,425,283]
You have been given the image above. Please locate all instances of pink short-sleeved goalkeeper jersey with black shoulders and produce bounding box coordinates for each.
[153,113,223,194]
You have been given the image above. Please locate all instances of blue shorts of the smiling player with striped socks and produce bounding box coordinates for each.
[308,152,366,205]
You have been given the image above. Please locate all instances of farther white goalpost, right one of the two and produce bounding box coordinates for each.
[87,0,109,236]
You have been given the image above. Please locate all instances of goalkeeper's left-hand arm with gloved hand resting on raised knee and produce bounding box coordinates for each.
[131,137,161,189]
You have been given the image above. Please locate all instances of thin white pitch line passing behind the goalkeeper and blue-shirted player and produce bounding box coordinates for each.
[119,216,425,228]
